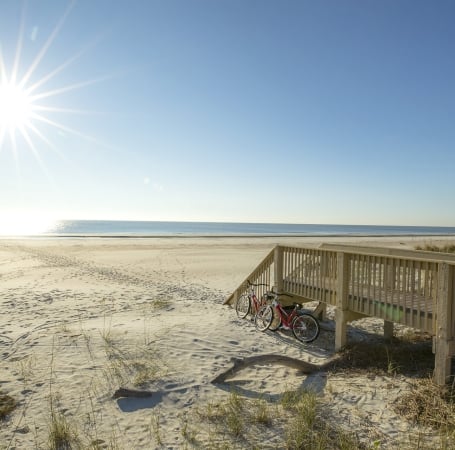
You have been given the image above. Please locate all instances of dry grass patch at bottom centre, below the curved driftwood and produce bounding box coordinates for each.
[192,390,367,450]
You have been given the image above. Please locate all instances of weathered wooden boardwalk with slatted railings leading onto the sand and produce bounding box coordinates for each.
[225,245,455,384]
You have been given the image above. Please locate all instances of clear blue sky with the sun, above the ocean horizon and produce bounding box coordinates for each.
[0,0,455,226]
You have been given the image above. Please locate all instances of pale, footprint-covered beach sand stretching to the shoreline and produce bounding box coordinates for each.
[0,237,453,449]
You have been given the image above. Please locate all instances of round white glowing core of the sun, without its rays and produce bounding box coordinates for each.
[0,81,33,134]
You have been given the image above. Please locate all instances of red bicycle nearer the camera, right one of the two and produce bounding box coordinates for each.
[254,292,321,343]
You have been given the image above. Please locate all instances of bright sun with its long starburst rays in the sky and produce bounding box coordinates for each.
[0,1,107,160]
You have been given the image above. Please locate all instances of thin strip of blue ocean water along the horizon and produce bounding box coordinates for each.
[40,220,455,237]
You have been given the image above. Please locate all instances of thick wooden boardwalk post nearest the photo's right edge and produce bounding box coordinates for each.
[434,263,453,386]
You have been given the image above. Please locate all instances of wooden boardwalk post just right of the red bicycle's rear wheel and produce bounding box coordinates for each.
[335,252,349,351]
